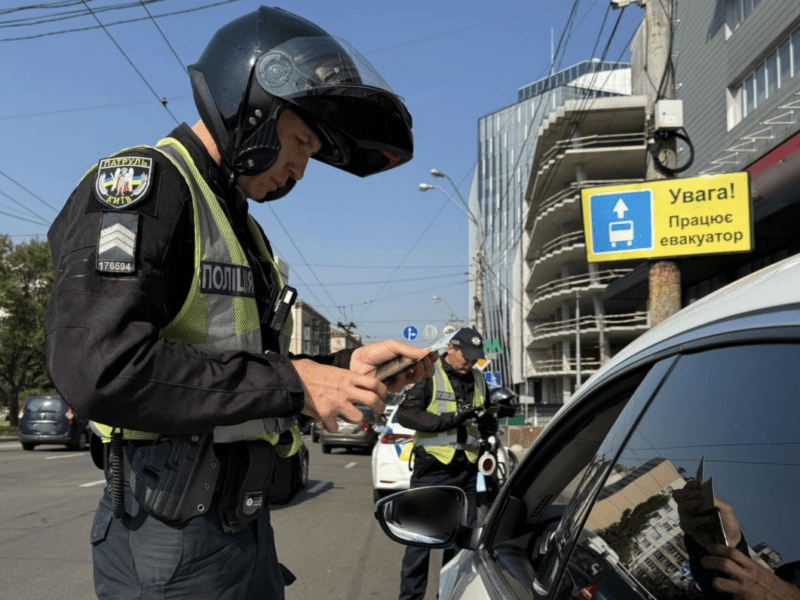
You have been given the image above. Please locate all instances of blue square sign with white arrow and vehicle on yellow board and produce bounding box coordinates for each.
[589,190,655,254]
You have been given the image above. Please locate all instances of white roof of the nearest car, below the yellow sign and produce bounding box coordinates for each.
[569,255,800,403]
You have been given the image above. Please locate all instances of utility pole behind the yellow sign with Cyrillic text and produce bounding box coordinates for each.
[624,0,681,327]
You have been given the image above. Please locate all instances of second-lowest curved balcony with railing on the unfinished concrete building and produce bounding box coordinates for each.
[527,311,650,350]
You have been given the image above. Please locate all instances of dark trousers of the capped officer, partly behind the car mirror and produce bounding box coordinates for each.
[400,450,478,600]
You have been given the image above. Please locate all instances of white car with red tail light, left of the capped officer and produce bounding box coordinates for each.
[372,405,414,501]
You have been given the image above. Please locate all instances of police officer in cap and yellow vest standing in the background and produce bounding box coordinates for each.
[397,327,498,600]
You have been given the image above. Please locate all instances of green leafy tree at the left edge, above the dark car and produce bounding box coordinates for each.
[0,236,54,425]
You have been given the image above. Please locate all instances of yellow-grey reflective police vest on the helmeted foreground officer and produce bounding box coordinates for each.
[87,138,302,457]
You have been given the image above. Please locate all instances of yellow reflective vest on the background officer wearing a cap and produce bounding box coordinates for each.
[414,358,486,465]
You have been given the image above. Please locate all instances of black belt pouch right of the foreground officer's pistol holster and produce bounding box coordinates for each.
[217,442,278,533]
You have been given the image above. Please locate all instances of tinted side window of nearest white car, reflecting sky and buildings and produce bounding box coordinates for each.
[556,344,800,600]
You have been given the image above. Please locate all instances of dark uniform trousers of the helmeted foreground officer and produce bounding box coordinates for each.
[91,448,294,600]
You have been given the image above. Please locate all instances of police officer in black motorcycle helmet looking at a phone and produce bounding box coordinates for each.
[46,7,435,600]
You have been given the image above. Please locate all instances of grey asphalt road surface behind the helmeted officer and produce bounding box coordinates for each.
[0,438,441,600]
